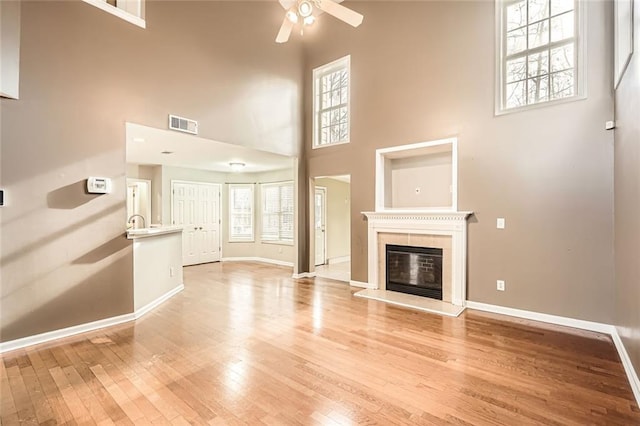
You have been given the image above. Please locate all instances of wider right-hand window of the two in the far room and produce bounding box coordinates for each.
[260,182,293,244]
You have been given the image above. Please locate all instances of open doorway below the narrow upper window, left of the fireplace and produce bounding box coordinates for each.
[312,175,351,282]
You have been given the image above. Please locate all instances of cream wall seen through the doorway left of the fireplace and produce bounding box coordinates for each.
[315,178,351,262]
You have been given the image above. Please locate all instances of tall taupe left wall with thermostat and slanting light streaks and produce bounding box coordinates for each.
[0,1,303,341]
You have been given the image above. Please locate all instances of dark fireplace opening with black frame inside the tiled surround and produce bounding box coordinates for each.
[386,244,442,300]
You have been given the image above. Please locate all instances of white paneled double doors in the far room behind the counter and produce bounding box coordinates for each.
[171,181,220,266]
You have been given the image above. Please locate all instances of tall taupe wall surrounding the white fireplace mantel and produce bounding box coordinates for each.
[305,1,613,323]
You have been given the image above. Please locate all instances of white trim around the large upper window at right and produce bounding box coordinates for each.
[494,0,588,116]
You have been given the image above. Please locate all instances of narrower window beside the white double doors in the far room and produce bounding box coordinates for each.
[229,184,254,242]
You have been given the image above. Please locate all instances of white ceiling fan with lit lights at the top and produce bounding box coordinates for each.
[276,0,364,43]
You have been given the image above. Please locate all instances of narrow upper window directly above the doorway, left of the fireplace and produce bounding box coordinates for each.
[313,56,351,148]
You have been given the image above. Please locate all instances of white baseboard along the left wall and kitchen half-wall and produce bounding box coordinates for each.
[0,284,184,354]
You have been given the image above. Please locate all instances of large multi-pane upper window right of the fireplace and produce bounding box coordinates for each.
[497,0,584,112]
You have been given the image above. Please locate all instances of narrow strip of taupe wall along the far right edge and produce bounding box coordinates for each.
[614,0,640,386]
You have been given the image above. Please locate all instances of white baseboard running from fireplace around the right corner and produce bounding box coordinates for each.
[466,300,640,405]
